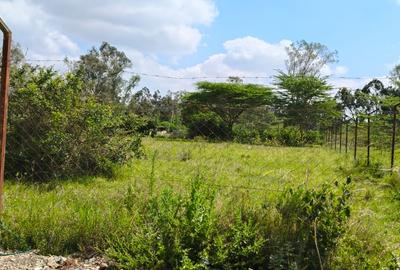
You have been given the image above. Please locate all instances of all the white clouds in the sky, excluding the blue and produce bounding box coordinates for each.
[0,0,360,92]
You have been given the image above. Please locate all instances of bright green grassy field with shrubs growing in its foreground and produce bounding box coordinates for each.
[0,138,400,269]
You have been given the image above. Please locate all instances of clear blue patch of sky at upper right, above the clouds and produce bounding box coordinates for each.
[181,0,400,76]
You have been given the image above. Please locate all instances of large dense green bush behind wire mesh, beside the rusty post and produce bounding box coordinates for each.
[6,68,143,180]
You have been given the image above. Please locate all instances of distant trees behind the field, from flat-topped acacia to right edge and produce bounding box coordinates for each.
[130,41,400,146]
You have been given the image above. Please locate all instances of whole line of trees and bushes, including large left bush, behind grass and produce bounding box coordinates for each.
[6,41,400,179]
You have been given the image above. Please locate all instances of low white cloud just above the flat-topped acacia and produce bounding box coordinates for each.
[133,37,291,92]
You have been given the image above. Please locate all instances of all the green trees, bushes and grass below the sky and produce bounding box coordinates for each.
[0,41,400,269]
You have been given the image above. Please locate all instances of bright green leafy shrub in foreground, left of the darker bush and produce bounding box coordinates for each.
[107,180,215,269]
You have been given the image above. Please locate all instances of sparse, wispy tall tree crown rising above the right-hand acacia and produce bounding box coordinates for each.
[285,40,337,76]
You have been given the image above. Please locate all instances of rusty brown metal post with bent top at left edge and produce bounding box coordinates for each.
[0,18,11,213]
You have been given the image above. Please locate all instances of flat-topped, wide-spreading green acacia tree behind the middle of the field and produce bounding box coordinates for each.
[183,82,273,139]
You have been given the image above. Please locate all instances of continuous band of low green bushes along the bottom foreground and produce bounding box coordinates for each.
[107,180,350,269]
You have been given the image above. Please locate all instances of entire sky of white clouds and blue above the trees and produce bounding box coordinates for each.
[0,0,400,92]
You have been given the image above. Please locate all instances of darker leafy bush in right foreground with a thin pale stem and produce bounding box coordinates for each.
[271,179,351,269]
